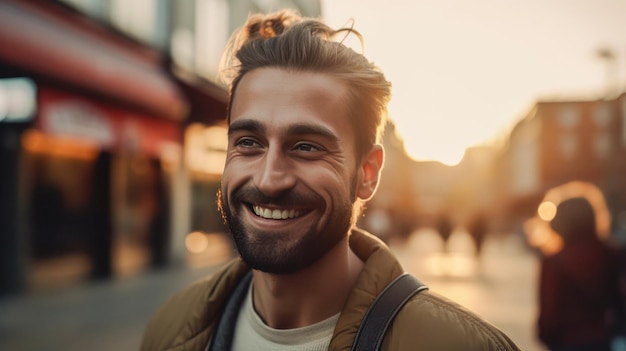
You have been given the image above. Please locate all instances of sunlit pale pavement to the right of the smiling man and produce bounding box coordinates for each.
[391,230,546,351]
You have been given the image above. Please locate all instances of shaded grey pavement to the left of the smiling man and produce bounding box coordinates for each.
[0,267,223,351]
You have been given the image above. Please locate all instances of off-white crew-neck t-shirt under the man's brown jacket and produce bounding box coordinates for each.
[233,284,339,351]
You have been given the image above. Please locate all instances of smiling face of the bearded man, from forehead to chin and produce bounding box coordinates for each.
[221,68,362,274]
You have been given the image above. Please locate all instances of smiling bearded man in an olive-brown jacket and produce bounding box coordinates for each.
[142,11,518,351]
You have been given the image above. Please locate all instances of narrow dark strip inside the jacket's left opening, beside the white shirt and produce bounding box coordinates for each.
[207,271,252,351]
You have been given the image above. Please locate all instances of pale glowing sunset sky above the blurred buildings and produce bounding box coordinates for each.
[322,0,626,165]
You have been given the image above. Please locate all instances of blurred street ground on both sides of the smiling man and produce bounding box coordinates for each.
[0,230,543,351]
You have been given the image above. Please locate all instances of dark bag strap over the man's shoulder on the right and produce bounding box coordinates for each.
[352,273,428,351]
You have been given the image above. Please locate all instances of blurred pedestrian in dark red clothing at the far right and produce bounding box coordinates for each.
[538,197,621,351]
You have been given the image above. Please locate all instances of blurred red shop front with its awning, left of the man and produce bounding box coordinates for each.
[0,0,225,293]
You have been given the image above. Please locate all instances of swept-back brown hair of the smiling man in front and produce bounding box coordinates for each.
[217,10,391,157]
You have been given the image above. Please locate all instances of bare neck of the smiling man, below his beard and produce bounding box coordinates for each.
[253,237,363,329]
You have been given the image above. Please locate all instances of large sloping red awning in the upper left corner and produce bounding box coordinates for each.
[0,0,188,121]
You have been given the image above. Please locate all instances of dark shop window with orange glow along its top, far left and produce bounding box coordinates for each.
[22,130,98,289]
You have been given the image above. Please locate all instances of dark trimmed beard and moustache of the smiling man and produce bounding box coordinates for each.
[218,179,356,274]
